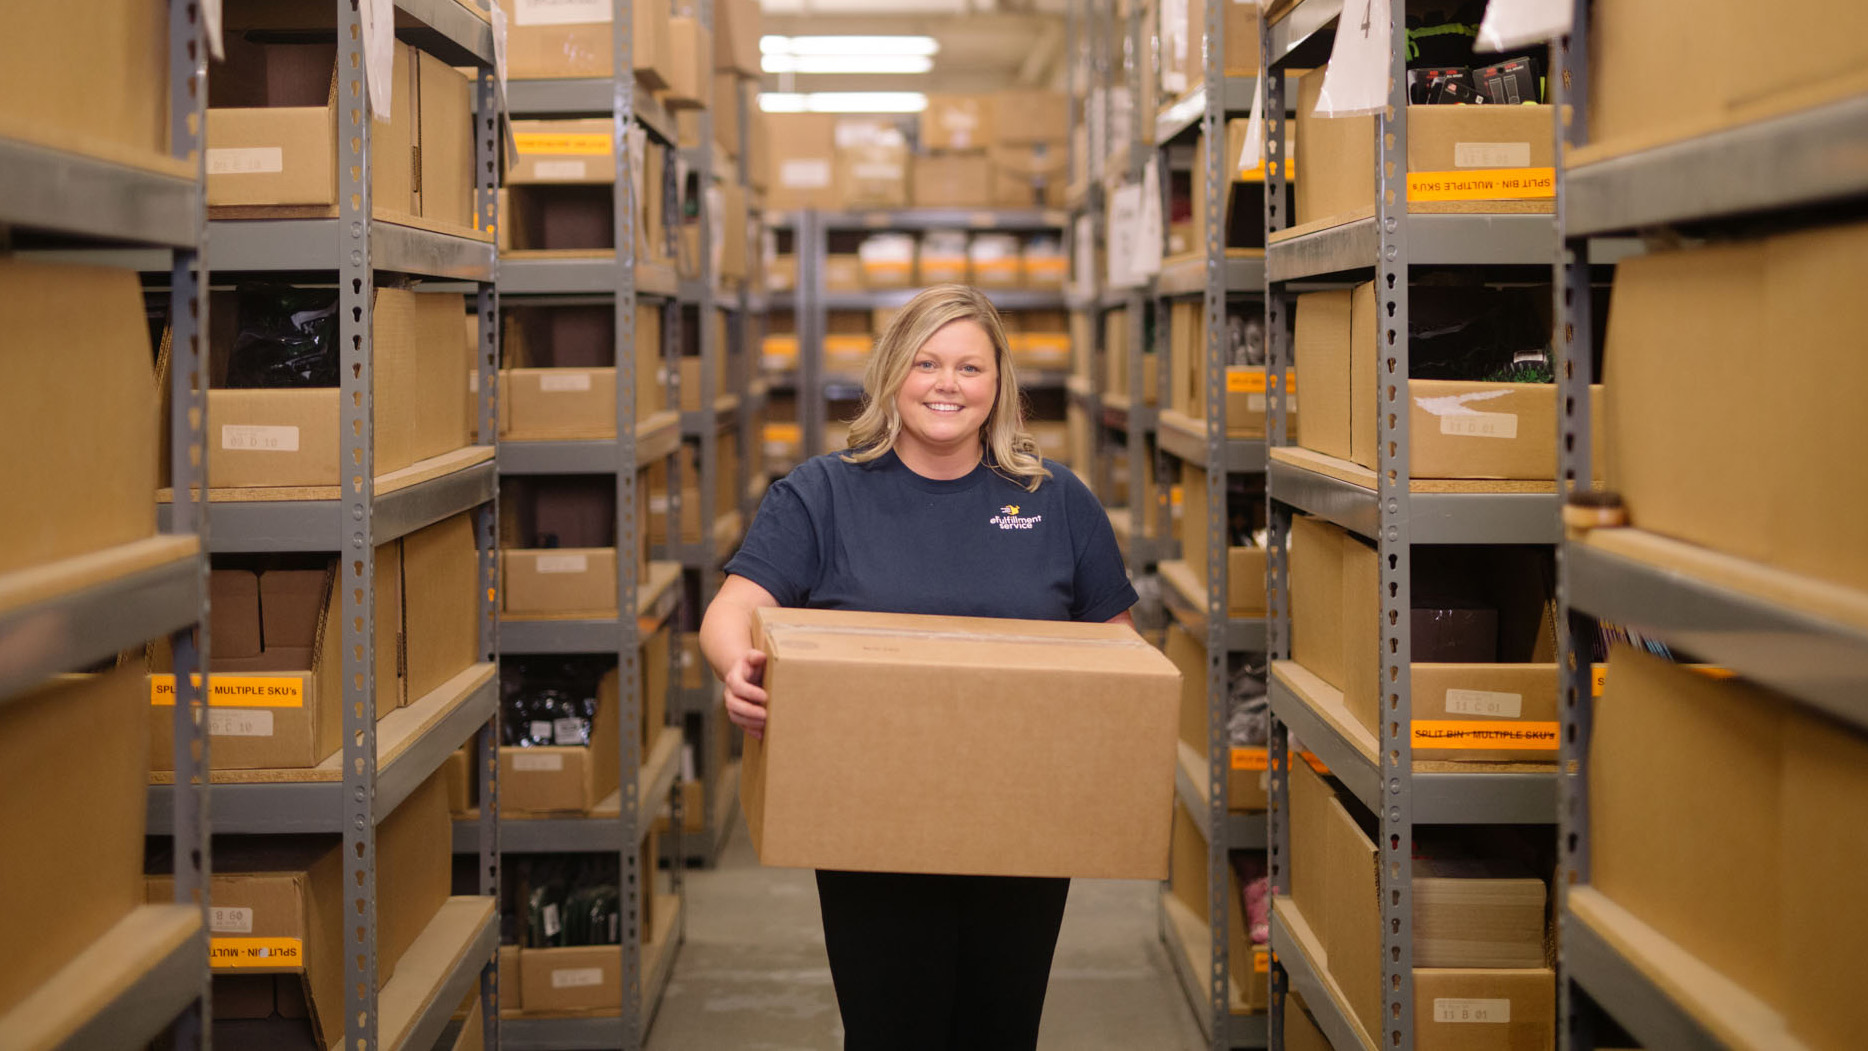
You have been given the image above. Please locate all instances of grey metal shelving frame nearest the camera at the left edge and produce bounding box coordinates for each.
[0,0,213,1047]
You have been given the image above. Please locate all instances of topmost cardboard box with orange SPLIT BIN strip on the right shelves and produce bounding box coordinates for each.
[1293,69,1554,226]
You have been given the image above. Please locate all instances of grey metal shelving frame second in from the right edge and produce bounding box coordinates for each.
[1259,0,1562,1049]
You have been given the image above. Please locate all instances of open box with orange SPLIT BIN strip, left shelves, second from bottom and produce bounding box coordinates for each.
[148,541,405,771]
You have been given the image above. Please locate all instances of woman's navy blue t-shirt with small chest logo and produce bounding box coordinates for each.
[727,452,1136,622]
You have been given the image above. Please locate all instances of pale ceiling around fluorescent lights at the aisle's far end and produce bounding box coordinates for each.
[762,0,1067,93]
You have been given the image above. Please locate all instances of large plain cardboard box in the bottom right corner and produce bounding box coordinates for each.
[1590,648,1868,1051]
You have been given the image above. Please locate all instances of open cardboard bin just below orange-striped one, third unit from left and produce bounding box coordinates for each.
[499,306,667,441]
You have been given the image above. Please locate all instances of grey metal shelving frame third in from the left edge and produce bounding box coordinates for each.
[481,0,706,1049]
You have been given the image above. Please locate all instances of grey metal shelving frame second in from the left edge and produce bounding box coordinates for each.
[173,0,499,1047]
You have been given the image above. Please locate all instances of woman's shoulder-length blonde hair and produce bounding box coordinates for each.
[842,284,1052,491]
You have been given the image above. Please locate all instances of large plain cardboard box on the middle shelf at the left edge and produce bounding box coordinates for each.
[0,263,166,573]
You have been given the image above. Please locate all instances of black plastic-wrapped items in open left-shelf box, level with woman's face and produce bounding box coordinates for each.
[222,286,338,388]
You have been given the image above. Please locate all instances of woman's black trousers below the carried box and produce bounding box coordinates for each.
[816,870,1070,1051]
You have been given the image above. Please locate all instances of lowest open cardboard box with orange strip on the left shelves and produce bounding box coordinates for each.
[144,773,454,1047]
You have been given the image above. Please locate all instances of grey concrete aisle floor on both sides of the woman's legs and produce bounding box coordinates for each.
[648,820,1203,1051]
